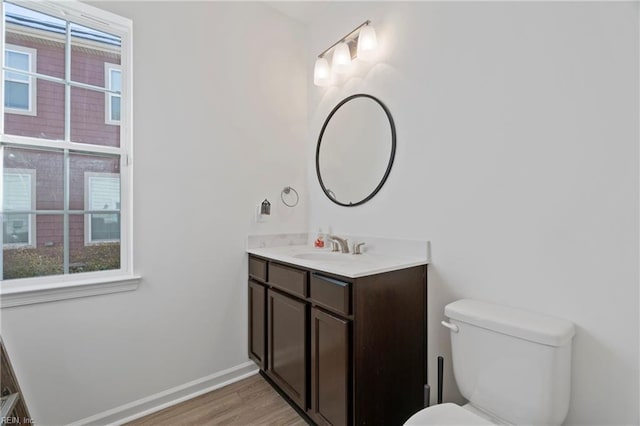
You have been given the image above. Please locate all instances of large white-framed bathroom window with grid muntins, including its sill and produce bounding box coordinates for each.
[0,1,139,307]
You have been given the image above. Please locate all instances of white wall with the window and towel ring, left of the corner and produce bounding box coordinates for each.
[2,2,307,425]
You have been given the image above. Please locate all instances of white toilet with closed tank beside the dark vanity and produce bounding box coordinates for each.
[405,299,575,426]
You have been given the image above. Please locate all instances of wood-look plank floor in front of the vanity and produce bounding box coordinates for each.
[127,374,307,426]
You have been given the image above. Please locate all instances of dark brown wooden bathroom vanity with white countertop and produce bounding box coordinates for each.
[249,247,427,425]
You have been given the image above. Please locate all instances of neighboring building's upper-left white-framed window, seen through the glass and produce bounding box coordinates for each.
[4,44,36,115]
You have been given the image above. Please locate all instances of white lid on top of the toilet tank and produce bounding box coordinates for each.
[444,299,575,346]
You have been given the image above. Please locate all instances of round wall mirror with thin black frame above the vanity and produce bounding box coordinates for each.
[316,94,396,207]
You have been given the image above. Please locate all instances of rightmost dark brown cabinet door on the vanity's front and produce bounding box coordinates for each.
[311,307,351,425]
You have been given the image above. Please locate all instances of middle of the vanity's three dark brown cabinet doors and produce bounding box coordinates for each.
[267,289,308,410]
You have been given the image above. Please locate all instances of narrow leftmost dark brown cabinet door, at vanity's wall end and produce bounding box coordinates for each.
[249,281,267,370]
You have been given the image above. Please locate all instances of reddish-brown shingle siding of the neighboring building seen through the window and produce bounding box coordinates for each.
[4,32,120,250]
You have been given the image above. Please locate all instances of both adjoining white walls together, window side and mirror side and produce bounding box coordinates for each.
[1,2,640,425]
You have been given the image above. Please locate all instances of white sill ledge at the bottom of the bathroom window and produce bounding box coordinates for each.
[0,275,141,308]
